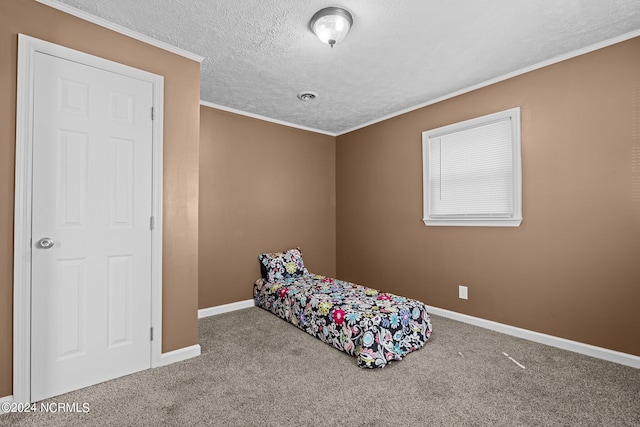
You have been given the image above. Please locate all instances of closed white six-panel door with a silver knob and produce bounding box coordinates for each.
[31,52,153,401]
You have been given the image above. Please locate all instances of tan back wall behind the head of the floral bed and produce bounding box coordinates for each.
[199,107,336,308]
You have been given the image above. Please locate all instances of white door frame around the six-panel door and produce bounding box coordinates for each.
[13,34,164,402]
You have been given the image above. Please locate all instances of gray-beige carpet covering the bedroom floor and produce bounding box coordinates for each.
[0,308,640,426]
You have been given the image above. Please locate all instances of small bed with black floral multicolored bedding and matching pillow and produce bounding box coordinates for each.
[254,248,432,368]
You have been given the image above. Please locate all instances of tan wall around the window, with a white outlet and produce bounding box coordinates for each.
[336,38,640,355]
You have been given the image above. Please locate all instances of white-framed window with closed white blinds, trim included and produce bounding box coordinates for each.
[422,108,522,227]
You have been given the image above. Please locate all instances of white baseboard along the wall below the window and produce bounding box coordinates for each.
[427,306,640,369]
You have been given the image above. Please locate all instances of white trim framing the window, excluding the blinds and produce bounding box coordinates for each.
[422,107,522,227]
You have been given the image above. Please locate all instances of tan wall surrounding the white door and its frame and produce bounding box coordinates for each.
[0,0,200,397]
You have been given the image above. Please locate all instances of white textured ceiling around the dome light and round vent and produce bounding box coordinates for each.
[46,0,640,134]
